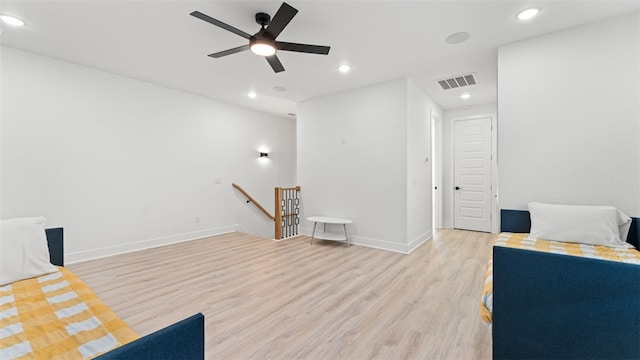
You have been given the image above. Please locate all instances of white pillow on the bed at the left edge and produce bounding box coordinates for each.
[0,217,57,286]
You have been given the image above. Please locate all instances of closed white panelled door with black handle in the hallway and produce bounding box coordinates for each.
[453,117,491,232]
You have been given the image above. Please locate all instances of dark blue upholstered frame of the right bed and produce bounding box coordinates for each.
[492,210,640,359]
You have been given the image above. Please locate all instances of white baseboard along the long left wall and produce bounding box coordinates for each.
[64,224,241,264]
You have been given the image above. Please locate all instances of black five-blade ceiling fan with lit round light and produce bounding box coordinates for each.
[191,2,330,73]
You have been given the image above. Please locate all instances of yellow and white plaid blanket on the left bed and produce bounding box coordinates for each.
[0,267,138,360]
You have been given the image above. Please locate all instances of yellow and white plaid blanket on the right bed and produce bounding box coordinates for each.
[480,233,640,327]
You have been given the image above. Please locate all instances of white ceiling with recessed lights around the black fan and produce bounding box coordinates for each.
[0,0,640,116]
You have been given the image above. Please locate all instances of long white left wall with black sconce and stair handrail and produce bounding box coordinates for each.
[0,47,295,261]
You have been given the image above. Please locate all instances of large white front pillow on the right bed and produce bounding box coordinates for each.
[529,202,633,248]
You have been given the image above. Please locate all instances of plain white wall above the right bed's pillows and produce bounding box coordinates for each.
[498,13,640,217]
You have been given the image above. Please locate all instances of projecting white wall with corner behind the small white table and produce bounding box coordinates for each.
[297,78,439,252]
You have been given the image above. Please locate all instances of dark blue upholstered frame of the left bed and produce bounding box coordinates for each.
[46,228,204,360]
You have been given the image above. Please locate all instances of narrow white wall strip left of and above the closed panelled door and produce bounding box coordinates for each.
[442,104,497,228]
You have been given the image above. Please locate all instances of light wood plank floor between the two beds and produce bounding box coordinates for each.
[69,230,493,359]
